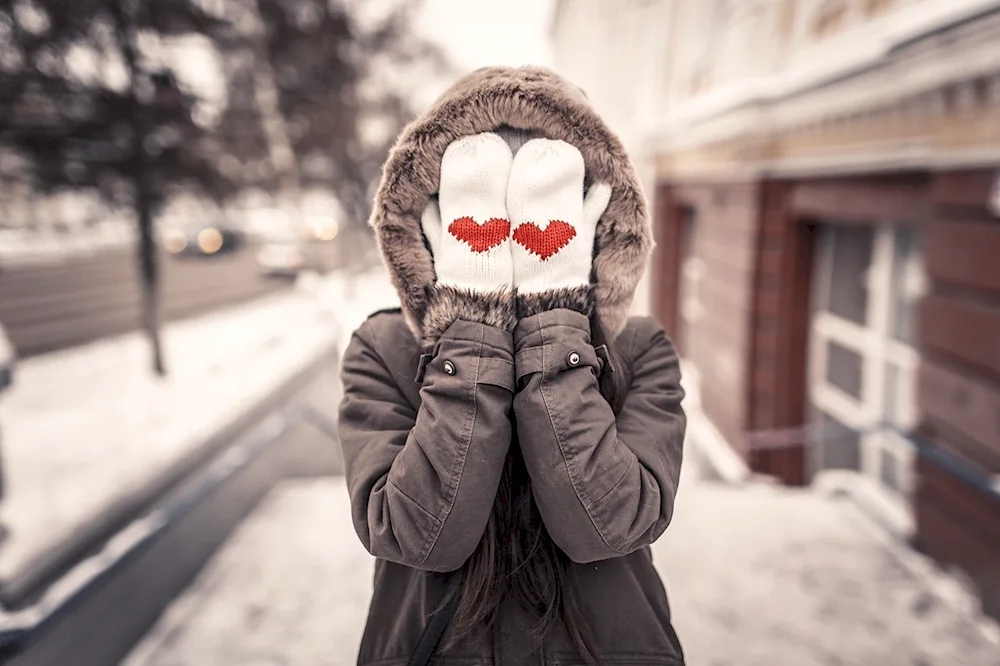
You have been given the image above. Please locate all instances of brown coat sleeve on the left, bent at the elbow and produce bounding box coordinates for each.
[339,320,514,571]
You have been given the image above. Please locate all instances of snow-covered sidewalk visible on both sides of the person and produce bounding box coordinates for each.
[125,446,1000,666]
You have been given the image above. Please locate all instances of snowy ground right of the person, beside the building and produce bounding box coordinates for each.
[653,456,1000,666]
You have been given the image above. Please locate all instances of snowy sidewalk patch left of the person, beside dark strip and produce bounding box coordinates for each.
[123,478,375,666]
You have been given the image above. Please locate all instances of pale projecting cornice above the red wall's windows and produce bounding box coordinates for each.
[641,3,1000,175]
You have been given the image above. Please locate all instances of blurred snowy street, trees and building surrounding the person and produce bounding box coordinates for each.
[0,0,1000,666]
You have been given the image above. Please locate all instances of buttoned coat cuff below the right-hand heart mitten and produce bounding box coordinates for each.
[513,309,602,381]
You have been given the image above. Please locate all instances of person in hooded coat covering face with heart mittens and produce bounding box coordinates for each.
[339,68,686,666]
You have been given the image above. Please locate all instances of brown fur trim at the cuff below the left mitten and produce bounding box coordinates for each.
[419,285,517,350]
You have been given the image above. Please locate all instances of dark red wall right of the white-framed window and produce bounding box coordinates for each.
[914,171,1000,615]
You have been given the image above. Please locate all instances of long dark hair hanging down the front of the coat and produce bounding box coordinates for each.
[447,316,632,665]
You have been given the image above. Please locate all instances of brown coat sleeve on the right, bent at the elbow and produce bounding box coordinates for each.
[514,309,686,563]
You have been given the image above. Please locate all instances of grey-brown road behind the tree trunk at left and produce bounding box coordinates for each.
[0,235,351,357]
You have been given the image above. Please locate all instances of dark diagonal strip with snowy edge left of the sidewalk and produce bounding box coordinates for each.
[0,341,339,666]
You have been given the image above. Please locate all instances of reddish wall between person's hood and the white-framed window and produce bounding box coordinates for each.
[654,176,814,484]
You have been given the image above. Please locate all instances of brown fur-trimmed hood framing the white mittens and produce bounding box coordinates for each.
[370,67,653,338]
